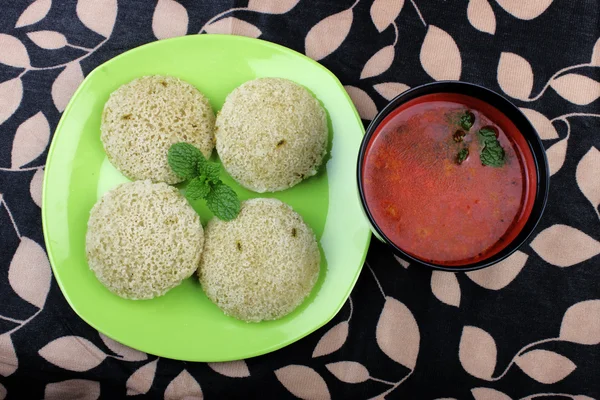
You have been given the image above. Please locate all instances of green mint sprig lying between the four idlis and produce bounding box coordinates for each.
[167,142,240,221]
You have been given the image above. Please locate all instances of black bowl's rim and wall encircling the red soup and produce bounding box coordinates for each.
[357,81,550,272]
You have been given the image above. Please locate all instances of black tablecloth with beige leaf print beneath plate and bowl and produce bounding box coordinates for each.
[0,0,600,400]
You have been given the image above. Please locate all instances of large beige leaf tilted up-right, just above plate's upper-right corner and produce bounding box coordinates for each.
[304,8,354,61]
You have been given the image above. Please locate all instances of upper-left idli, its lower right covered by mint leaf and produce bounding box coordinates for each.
[100,75,215,184]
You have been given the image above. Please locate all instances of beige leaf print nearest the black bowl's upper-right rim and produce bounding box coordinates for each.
[498,52,533,100]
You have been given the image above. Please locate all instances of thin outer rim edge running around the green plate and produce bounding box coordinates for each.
[41,34,372,362]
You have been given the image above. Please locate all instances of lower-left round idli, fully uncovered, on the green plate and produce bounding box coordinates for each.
[86,180,204,300]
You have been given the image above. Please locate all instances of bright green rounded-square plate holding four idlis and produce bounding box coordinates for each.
[42,35,371,361]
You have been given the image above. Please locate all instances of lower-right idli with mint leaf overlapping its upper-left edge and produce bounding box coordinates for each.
[198,198,321,322]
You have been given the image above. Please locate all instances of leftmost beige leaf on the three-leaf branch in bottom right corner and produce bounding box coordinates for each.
[458,326,497,381]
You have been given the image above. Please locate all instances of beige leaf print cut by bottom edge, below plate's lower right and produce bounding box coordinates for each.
[275,365,331,400]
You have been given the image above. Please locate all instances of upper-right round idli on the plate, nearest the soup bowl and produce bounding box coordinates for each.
[215,78,328,193]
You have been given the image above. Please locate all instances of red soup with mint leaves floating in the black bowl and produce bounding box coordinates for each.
[362,93,536,266]
